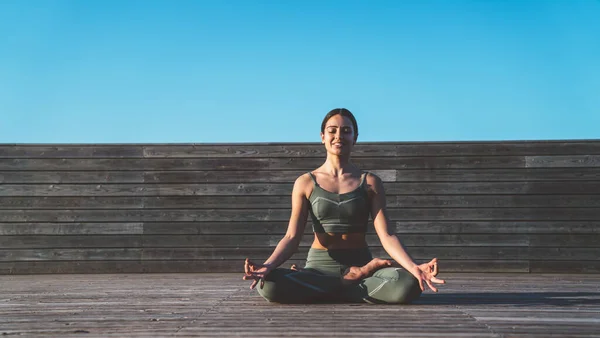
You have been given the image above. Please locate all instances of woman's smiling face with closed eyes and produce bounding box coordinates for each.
[321,114,354,155]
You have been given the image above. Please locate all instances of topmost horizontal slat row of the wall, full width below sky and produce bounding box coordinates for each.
[0,140,600,158]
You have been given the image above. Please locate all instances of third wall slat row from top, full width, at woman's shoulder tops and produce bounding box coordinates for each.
[0,167,600,184]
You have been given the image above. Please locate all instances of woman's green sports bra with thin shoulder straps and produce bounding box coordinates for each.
[308,172,370,233]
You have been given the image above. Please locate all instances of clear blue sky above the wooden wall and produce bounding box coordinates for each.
[0,0,600,143]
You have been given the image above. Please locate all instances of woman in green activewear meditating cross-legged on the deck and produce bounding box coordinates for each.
[243,108,445,304]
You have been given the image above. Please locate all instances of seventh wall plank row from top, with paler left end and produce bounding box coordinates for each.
[0,220,600,238]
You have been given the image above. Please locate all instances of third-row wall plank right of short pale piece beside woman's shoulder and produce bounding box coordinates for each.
[396,167,600,182]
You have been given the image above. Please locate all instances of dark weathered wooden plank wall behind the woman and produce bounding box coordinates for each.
[0,140,600,274]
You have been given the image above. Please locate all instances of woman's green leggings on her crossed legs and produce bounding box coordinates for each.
[257,248,421,304]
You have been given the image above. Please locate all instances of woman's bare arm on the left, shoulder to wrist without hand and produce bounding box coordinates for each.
[263,175,312,269]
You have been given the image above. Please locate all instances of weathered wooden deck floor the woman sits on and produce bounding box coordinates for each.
[0,273,600,337]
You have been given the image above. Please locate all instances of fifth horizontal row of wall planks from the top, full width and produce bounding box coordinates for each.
[5,195,600,213]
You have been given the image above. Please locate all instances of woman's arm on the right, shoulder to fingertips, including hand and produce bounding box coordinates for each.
[367,174,445,292]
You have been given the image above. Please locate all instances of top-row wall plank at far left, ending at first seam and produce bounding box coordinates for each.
[0,144,144,158]
